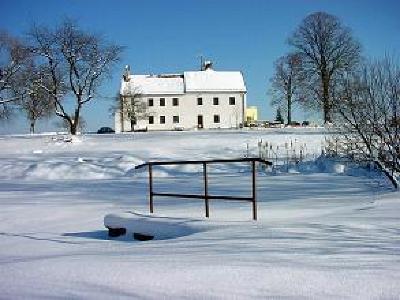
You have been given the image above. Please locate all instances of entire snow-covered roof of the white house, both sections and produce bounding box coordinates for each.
[121,69,246,95]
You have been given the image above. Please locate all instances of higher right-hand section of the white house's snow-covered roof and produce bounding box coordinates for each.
[184,69,246,92]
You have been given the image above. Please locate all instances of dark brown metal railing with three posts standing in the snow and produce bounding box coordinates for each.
[135,157,272,220]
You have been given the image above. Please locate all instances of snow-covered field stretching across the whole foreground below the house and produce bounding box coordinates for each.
[0,129,400,299]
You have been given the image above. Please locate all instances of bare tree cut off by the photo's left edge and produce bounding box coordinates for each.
[0,31,30,118]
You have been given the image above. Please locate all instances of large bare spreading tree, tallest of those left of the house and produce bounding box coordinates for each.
[29,20,123,134]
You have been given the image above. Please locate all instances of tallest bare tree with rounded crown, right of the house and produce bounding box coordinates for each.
[288,12,361,123]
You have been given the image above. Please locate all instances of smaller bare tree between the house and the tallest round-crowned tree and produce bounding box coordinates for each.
[270,54,303,125]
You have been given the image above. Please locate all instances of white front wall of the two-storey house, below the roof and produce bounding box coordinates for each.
[115,92,246,131]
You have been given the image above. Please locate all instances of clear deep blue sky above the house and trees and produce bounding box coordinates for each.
[0,0,400,132]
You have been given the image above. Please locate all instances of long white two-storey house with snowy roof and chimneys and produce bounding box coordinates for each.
[115,62,246,132]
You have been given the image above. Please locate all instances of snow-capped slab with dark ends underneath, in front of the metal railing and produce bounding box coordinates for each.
[104,212,209,240]
